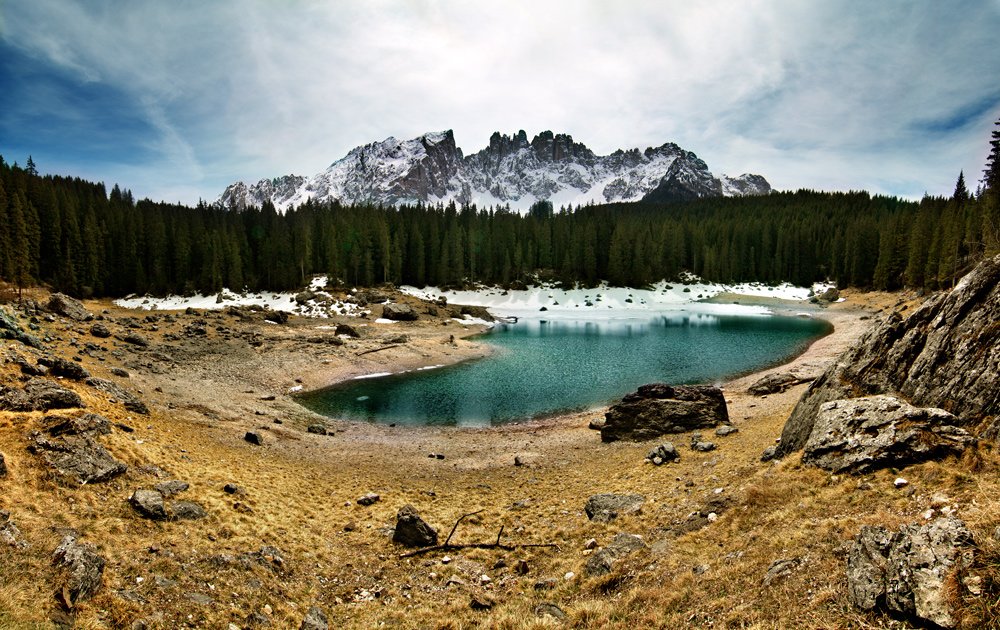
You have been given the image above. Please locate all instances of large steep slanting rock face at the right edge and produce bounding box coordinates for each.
[778,256,1000,457]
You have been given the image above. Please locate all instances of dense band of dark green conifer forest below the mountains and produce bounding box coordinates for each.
[0,158,1000,297]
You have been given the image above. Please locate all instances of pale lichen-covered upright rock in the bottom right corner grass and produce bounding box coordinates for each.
[847,516,975,628]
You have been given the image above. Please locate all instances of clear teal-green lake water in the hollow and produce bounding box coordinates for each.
[298,313,831,426]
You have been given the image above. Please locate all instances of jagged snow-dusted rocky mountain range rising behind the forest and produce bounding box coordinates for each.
[216,130,771,211]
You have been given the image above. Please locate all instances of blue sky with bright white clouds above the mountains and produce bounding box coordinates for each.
[0,0,1000,204]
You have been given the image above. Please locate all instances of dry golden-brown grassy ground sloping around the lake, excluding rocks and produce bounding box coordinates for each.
[0,294,1000,630]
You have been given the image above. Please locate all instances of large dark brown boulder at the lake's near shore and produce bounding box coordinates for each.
[601,383,729,442]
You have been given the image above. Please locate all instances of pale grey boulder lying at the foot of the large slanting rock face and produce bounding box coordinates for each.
[802,396,975,474]
